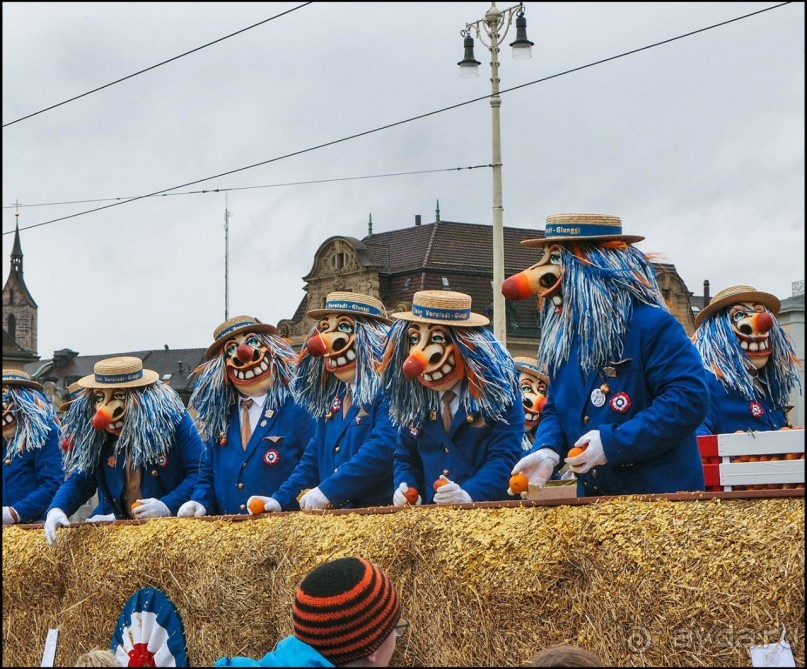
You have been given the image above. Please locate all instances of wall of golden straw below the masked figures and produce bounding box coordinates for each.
[3,497,804,666]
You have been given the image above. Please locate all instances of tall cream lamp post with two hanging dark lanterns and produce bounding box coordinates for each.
[457,2,533,346]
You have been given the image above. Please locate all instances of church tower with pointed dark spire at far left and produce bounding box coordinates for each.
[3,212,38,359]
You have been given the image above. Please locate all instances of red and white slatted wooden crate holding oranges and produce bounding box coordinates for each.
[698,429,804,491]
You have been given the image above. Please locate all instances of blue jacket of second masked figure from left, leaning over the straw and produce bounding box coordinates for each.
[48,411,204,519]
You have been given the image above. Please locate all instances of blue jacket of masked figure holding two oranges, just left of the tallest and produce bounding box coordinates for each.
[393,386,524,504]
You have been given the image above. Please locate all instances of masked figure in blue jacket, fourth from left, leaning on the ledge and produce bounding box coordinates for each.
[250,292,396,511]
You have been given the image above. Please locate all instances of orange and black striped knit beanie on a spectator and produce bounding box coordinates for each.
[292,558,401,666]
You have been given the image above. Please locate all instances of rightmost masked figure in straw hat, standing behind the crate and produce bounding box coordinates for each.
[692,286,801,434]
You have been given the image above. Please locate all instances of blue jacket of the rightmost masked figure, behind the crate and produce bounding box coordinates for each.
[698,371,787,435]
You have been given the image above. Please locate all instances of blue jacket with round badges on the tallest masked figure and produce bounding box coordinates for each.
[533,304,708,497]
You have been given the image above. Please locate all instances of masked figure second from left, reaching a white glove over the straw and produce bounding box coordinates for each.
[45,356,204,545]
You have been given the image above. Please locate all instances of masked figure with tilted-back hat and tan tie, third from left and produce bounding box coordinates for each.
[178,316,313,517]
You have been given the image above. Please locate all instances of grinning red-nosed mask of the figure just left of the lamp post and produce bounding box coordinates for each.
[403,323,465,391]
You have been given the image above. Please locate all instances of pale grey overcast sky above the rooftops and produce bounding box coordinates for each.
[3,2,805,359]
